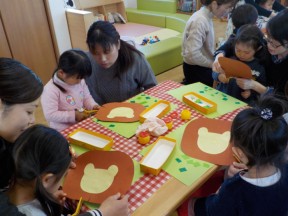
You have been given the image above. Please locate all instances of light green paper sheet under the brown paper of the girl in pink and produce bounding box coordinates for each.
[92,94,177,138]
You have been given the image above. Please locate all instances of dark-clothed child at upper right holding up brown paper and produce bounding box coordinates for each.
[212,25,266,105]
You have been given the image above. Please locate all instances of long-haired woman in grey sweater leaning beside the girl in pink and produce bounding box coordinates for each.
[85,21,157,105]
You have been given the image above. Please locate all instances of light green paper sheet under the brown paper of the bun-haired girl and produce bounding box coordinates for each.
[140,122,213,185]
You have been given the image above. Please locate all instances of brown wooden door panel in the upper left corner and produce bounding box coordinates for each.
[0,0,56,83]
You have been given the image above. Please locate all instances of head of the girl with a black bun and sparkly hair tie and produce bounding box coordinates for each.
[231,96,288,169]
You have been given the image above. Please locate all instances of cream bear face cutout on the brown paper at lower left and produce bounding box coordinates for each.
[80,163,118,194]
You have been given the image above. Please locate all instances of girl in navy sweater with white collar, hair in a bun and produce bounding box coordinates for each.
[189,96,288,216]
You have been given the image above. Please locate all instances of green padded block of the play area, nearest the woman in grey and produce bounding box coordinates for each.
[139,37,183,75]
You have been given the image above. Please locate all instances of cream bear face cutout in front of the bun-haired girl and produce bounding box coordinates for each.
[197,127,230,154]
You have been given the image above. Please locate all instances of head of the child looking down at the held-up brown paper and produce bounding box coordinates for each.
[235,24,264,62]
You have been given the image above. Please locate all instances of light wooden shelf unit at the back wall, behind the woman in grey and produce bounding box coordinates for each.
[66,0,127,50]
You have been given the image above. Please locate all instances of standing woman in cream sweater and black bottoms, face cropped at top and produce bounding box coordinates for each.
[182,0,235,86]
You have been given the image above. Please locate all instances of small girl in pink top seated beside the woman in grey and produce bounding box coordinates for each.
[41,50,99,131]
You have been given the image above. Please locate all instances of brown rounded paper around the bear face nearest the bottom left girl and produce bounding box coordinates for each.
[63,150,134,203]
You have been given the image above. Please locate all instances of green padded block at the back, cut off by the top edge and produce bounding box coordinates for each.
[137,0,177,13]
